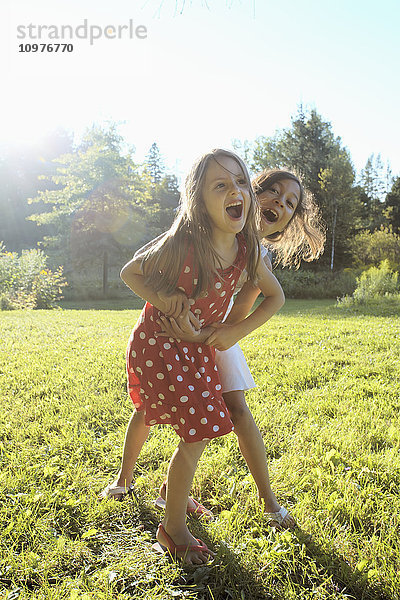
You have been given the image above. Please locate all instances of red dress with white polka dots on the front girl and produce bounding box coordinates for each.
[126,234,246,442]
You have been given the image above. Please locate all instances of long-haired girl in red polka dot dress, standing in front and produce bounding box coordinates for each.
[108,150,284,564]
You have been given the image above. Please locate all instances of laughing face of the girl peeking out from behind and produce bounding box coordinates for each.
[257,179,300,237]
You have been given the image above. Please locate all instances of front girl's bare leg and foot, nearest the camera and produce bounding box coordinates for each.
[157,441,216,565]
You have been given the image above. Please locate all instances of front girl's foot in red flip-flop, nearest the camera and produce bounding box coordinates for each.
[156,523,215,565]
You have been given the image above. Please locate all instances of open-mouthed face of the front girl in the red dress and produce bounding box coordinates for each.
[202,155,251,235]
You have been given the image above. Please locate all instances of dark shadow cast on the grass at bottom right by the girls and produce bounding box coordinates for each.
[166,520,393,600]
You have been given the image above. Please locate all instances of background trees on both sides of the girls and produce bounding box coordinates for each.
[0,106,400,291]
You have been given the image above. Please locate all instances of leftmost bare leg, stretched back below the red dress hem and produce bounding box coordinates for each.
[101,410,150,500]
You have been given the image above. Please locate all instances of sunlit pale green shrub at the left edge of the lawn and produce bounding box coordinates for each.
[0,243,67,310]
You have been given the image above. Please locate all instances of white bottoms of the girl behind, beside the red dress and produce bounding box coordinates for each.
[215,344,256,393]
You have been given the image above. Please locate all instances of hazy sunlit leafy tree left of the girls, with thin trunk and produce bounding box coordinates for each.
[27,125,150,290]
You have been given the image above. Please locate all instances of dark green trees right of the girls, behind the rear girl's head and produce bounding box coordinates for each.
[234,106,400,270]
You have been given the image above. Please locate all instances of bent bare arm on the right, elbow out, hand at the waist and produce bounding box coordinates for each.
[206,261,285,350]
